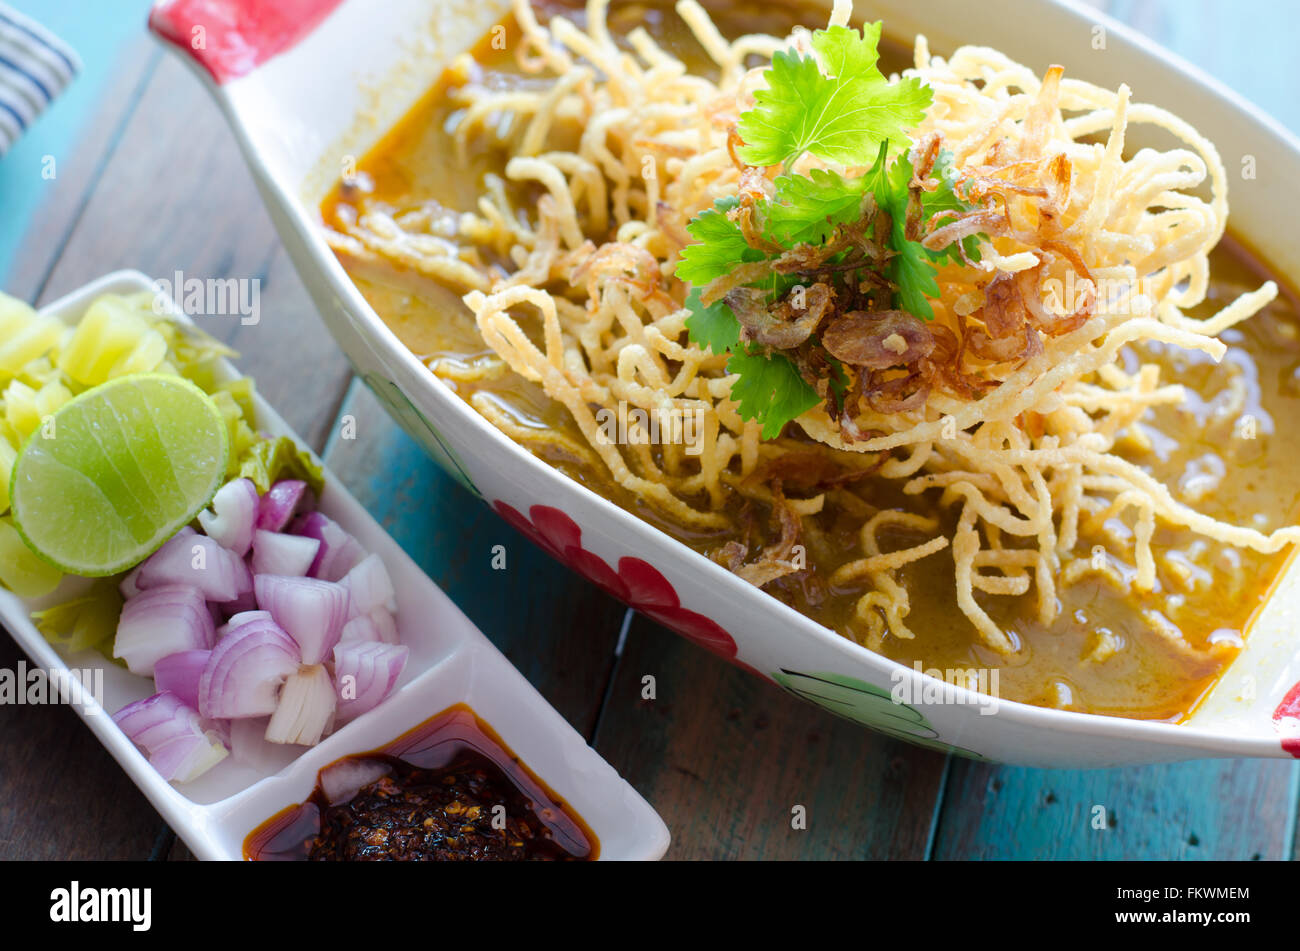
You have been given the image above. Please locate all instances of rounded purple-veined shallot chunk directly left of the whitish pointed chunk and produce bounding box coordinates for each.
[199,618,298,720]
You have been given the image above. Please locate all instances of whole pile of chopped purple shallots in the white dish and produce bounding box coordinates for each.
[114,479,410,774]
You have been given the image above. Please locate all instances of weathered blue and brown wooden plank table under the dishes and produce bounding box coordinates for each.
[0,0,1300,859]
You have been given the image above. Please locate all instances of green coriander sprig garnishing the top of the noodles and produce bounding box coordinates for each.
[676,22,978,439]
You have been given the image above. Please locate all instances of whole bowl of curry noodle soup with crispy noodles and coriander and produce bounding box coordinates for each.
[151,0,1300,767]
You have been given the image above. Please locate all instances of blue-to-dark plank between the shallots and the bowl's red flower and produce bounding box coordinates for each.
[326,383,625,738]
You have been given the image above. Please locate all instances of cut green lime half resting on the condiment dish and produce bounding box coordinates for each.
[9,374,230,576]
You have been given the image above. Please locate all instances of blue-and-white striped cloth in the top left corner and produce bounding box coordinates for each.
[0,3,81,156]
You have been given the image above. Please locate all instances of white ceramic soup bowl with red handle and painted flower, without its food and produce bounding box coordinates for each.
[151,0,1300,767]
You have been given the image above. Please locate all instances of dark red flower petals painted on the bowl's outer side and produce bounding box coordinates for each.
[493,500,757,659]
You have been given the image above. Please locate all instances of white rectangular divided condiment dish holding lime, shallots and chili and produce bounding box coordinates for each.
[0,272,668,859]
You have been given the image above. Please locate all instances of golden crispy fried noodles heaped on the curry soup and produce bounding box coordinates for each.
[327,0,1300,653]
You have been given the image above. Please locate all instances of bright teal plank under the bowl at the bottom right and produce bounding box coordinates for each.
[935,760,1296,860]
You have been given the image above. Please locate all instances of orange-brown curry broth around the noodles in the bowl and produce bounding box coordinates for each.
[321,3,1300,721]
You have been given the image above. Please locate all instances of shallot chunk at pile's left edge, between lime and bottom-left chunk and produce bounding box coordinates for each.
[113,585,213,676]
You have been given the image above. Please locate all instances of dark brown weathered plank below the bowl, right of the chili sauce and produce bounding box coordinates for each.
[594,615,945,859]
